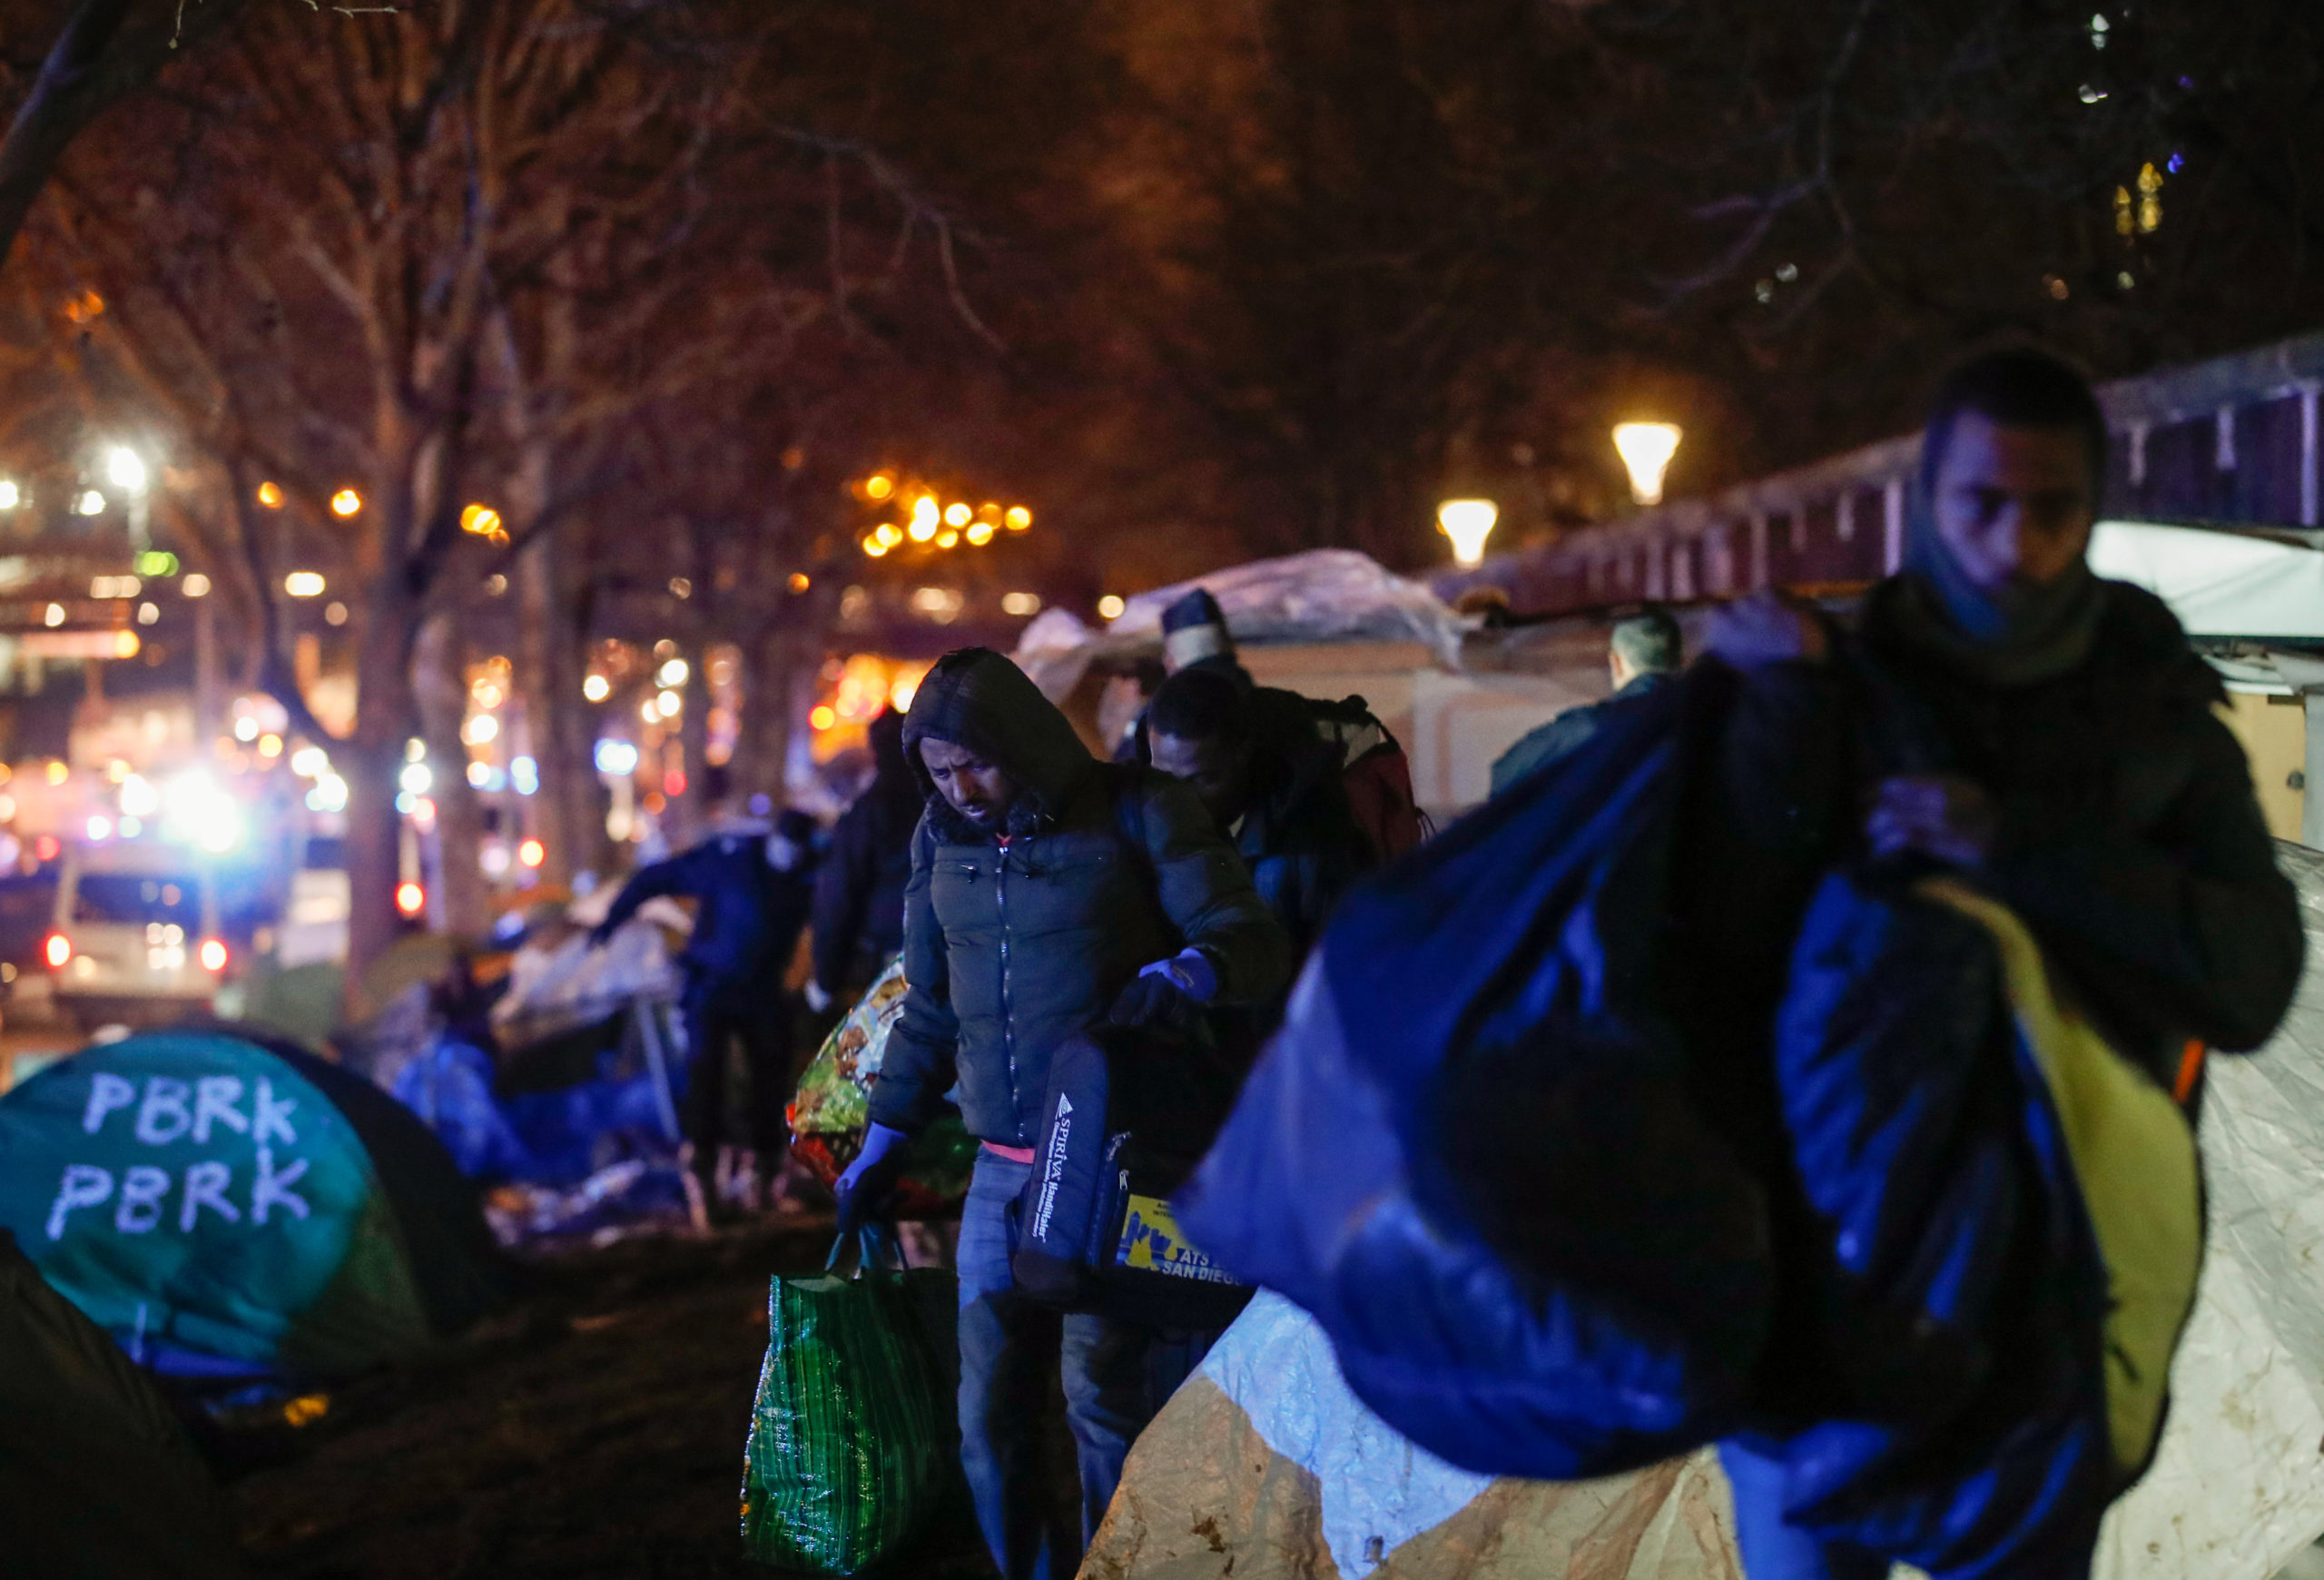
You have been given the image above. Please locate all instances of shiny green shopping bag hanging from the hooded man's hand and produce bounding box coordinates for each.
[742,1231,960,1575]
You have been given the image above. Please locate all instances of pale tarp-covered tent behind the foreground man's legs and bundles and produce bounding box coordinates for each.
[1080,844,2324,1580]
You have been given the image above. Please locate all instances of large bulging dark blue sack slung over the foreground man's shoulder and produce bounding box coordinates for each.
[1176,672,1773,1480]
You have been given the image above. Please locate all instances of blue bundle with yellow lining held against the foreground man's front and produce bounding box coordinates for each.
[1752,872,2201,1580]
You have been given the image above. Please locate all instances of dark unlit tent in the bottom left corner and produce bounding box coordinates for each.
[0,1234,244,1580]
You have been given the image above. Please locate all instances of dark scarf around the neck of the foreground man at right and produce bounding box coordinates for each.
[1868,492,2105,687]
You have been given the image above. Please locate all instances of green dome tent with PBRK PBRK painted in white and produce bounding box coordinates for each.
[0,1032,502,1376]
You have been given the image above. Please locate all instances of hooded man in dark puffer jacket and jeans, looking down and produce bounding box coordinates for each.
[839,648,1287,1580]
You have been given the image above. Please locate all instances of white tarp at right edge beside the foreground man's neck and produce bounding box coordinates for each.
[2089,520,2324,639]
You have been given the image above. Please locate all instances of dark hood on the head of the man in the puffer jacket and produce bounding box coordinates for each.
[904,648,1097,844]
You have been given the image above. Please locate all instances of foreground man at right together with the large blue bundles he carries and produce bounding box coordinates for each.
[1178,351,2303,1580]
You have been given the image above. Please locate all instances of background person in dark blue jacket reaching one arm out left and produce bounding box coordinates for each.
[590,766,816,1227]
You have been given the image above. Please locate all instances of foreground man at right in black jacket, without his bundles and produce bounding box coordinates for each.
[1709,351,2306,1580]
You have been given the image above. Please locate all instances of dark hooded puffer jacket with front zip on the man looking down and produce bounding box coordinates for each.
[872,648,1290,1146]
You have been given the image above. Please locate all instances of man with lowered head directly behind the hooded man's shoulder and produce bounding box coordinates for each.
[1146,665,1378,1022]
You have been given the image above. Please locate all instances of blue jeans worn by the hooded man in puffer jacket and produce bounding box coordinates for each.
[958,1148,1216,1580]
